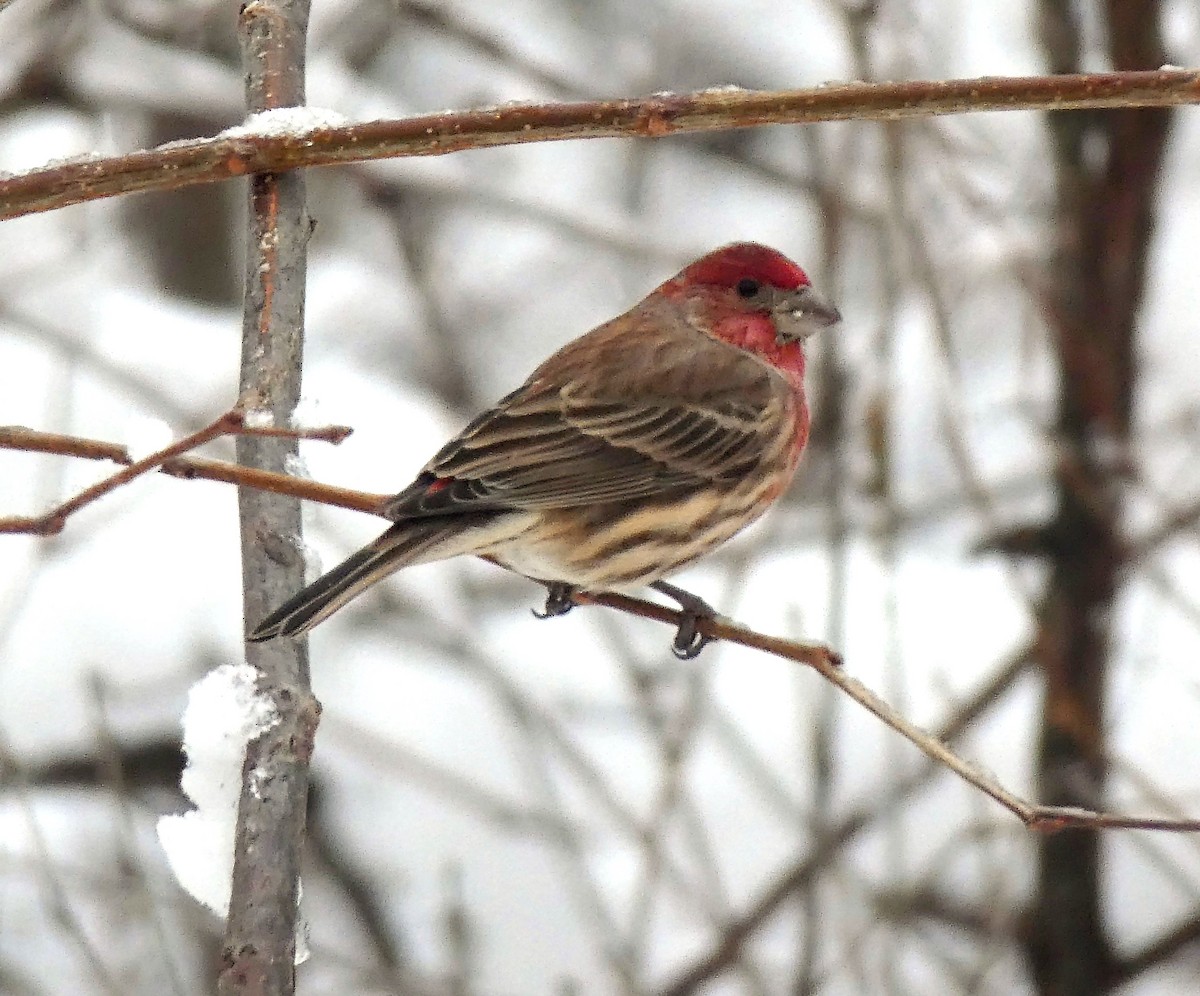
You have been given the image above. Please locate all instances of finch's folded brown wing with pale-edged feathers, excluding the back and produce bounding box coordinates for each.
[382,343,785,520]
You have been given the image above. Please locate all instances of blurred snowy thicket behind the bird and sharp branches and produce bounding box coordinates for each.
[0,0,1200,996]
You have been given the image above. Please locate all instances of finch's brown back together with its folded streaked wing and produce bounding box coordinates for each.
[384,302,790,518]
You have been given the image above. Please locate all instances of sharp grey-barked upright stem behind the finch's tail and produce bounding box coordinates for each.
[220,0,319,995]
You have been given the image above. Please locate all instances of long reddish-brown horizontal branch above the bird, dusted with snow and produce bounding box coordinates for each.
[0,70,1200,220]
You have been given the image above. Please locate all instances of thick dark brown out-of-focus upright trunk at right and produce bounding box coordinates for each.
[1030,0,1170,996]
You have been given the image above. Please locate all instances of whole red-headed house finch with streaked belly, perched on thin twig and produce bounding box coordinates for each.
[250,242,840,658]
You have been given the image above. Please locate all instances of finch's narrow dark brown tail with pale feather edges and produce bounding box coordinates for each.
[246,520,461,643]
